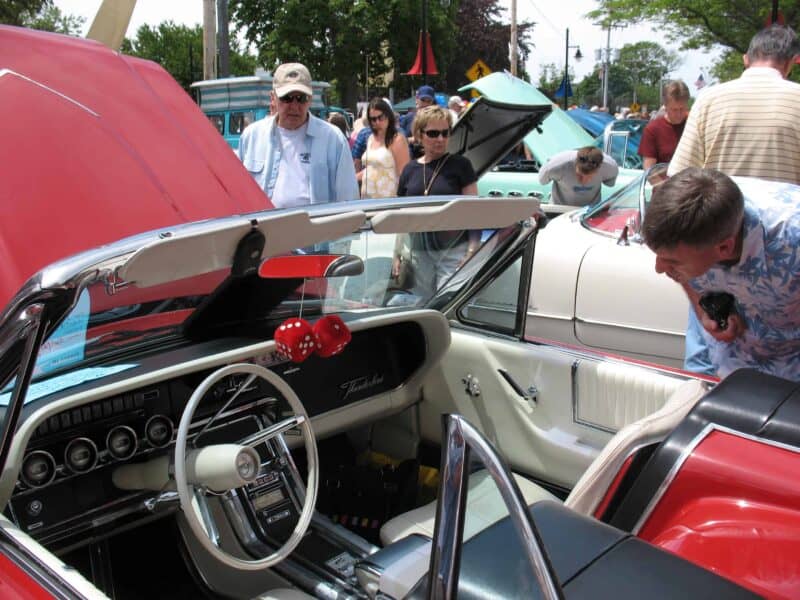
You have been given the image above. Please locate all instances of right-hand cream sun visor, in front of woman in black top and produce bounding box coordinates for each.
[371,198,539,233]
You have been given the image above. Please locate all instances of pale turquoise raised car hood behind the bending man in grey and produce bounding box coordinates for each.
[459,73,594,170]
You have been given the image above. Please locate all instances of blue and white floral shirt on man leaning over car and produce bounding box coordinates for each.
[687,179,800,381]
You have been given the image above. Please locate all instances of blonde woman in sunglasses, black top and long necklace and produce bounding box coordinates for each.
[392,106,480,304]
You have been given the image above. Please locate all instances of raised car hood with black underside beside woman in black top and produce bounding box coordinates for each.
[447,91,552,177]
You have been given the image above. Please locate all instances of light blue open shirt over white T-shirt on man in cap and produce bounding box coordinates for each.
[238,115,358,204]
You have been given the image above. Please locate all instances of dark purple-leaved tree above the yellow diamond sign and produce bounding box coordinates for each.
[445,0,534,90]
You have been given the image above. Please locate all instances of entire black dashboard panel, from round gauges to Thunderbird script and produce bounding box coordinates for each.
[10,322,426,546]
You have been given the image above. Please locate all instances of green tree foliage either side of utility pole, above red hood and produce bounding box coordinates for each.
[121,21,255,91]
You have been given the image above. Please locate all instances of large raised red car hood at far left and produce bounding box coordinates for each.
[0,26,272,307]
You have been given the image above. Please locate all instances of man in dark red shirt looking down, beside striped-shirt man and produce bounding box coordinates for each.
[638,80,689,169]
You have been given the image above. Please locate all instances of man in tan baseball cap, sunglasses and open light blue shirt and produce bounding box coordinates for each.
[238,63,358,208]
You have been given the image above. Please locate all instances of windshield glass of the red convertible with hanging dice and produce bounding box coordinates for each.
[28,225,519,392]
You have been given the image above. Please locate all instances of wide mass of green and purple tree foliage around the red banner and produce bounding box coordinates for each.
[230,0,532,106]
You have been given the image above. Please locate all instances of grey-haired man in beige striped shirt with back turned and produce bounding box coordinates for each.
[668,25,800,184]
